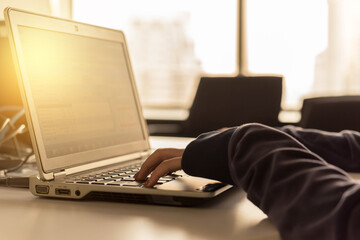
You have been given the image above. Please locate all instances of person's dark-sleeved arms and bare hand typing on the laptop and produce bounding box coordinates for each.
[134,123,360,240]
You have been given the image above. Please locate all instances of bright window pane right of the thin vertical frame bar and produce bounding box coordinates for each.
[246,0,360,109]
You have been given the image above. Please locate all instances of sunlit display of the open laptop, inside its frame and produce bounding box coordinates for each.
[18,26,145,158]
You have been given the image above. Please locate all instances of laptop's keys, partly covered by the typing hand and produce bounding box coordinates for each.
[64,163,182,187]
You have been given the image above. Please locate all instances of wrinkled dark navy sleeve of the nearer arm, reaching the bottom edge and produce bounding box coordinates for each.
[182,124,360,240]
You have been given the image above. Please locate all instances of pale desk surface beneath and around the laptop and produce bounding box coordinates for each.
[0,138,280,240]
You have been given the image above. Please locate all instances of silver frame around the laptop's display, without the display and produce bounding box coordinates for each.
[4,8,150,175]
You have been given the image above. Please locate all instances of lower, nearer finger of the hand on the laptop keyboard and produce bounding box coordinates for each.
[144,157,181,187]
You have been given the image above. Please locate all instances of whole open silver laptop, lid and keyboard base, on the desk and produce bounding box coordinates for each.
[4,8,231,205]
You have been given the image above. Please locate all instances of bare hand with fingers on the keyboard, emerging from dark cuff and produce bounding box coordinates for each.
[134,148,184,187]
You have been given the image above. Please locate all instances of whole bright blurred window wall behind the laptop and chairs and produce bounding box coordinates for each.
[0,0,360,133]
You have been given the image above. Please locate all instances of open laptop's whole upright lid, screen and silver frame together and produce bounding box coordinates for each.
[4,8,149,179]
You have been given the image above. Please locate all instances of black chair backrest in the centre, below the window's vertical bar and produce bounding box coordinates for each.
[182,76,282,137]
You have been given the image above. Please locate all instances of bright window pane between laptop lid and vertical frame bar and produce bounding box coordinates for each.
[73,0,237,108]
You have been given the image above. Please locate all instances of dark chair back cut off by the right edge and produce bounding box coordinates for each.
[299,96,360,132]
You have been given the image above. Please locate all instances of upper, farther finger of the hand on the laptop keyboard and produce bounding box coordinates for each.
[134,148,184,180]
